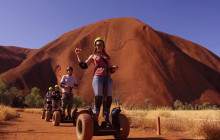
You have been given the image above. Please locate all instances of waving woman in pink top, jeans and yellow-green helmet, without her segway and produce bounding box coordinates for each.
[75,37,118,127]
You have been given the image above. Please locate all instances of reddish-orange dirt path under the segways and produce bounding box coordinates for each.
[0,112,198,140]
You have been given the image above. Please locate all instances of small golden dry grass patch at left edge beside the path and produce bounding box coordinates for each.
[0,105,19,123]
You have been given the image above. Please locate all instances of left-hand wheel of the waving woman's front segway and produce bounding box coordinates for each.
[76,114,94,140]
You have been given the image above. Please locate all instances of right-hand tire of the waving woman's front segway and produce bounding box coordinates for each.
[114,114,130,139]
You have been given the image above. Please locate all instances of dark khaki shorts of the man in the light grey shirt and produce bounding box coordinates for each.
[62,92,73,108]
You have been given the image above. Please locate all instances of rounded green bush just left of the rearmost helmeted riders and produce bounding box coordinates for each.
[24,87,44,108]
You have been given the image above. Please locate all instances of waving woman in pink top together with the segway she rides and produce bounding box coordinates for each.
[75,37,130,140]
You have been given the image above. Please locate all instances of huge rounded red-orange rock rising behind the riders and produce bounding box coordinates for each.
[0,18,220,106]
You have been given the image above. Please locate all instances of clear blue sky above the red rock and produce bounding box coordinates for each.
[0,0,220,56]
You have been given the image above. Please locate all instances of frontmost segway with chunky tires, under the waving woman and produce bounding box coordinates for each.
[75,67,130,140]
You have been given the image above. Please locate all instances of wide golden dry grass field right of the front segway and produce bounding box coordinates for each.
[122,108,220,139]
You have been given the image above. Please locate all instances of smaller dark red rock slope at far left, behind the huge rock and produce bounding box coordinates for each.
[0,46,32,74]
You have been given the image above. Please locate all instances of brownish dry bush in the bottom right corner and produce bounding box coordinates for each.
[197,121,220,140]
